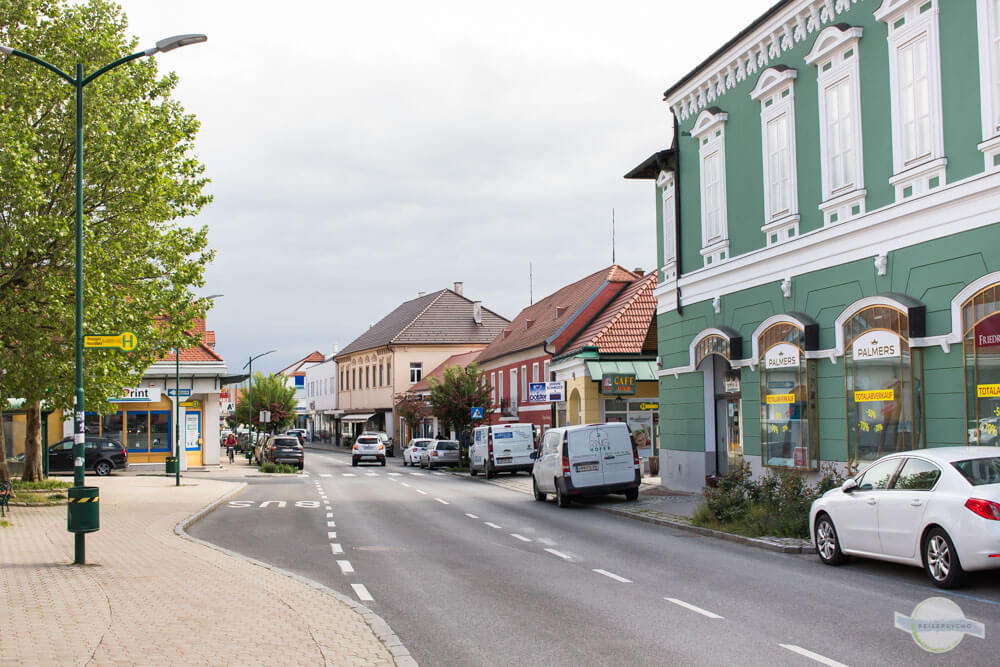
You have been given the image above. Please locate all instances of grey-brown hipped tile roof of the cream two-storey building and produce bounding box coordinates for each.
[337,289,509,359]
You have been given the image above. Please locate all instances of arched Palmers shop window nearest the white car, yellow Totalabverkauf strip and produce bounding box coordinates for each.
[844,305,924,466]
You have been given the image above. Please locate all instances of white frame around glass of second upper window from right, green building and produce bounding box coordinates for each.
[875,0,948,201]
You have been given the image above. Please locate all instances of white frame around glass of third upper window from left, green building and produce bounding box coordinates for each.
[750,67,799,247]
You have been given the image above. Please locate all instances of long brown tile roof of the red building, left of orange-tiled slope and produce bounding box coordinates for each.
[479,264,638,361]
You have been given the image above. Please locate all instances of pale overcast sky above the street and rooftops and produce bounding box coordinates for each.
[122,0,773,372]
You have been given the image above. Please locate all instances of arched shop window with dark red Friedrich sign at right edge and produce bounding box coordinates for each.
[962,283,1000,446]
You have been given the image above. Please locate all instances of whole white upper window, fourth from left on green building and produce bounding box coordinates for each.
[805,24,868,225]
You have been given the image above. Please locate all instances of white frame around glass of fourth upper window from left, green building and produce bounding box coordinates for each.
[805,25,868,225]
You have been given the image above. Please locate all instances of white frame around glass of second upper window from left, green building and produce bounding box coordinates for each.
[691,107,730,266]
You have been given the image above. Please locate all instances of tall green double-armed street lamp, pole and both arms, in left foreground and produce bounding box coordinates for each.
[0,35,208,565]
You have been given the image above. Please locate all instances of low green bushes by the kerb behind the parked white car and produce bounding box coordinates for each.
[691,463,844,537]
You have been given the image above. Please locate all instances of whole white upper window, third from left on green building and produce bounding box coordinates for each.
[750,65,799,246]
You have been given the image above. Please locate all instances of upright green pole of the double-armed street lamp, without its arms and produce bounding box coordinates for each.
[73,63,87,565]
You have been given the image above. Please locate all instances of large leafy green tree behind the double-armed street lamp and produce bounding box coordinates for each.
[0,0,214,480]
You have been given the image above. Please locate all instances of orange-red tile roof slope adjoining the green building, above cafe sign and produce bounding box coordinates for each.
[560,271,656,356]
